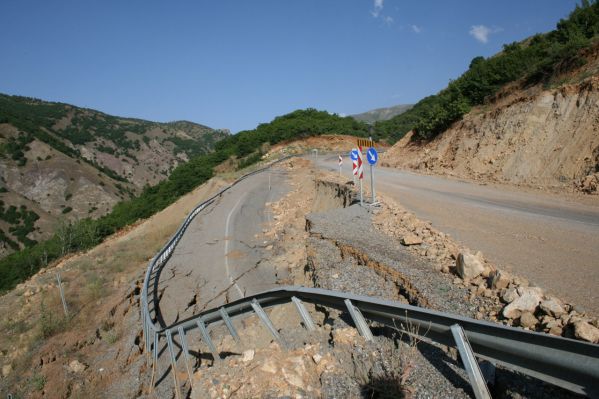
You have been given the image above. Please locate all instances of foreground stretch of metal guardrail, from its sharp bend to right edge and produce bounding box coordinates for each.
[164,287,599,397]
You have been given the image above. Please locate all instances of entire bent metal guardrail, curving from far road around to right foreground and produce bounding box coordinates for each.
[141,152,599,397]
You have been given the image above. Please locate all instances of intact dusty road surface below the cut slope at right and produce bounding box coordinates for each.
[316,156,599,315]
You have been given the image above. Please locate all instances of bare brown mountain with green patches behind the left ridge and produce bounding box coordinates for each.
[0,94,229,256]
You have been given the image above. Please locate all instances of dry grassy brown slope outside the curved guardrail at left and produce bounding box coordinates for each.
[0,175,227,397]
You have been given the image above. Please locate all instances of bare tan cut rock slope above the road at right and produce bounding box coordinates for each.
[382,53,599,193]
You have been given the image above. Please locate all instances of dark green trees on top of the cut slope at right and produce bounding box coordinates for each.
[373,0,599,142]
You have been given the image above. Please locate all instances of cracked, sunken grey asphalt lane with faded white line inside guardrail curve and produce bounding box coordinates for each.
[158,168,289,325]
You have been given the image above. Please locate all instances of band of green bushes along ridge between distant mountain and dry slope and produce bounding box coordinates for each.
[0,109,368,291]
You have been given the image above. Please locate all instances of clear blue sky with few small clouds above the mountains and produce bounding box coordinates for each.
[0,0,576,132]
